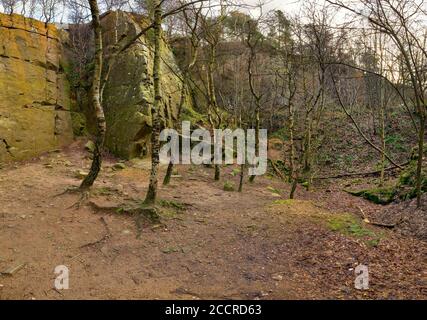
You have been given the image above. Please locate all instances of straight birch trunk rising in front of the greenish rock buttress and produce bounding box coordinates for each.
[144,0,162,204]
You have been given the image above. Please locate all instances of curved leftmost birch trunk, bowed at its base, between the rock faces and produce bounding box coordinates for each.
[80,0,106,190]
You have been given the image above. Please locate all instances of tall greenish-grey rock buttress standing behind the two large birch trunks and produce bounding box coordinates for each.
[101,11,191,159]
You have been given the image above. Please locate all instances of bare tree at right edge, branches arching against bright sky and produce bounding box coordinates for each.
[327,0,427,207]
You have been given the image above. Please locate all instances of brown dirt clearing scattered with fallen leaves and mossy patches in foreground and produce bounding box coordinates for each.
[0,143,427,299]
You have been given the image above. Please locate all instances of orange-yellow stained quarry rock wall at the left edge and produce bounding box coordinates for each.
[0,14,73,162]
